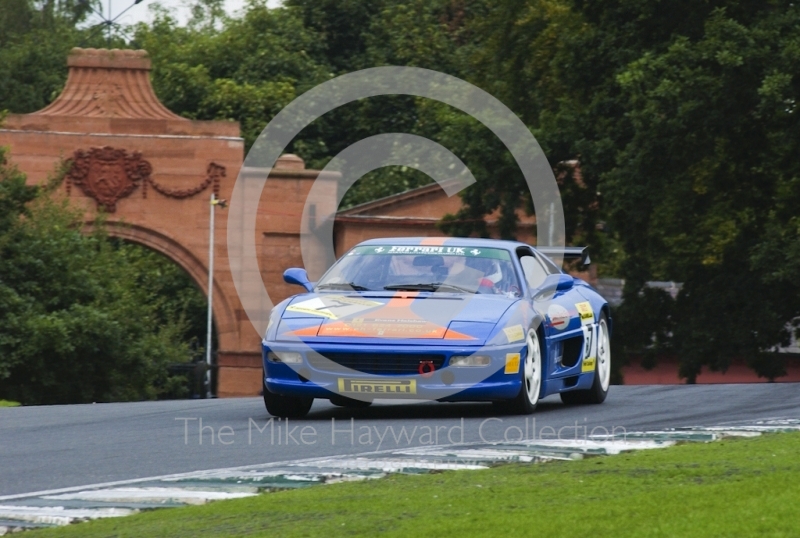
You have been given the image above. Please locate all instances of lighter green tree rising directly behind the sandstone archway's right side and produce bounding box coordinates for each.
[129,0,330,149]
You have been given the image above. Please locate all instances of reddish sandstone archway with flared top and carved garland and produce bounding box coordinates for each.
[0,49,335,396]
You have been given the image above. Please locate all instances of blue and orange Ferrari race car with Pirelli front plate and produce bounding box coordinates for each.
[262,237,611,417]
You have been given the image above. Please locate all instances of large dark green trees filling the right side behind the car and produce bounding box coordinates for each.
[472,0,800,381]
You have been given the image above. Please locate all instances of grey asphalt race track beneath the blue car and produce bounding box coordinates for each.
[0,383,800,496]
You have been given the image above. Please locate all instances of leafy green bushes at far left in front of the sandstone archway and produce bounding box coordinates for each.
[0,151,202,404]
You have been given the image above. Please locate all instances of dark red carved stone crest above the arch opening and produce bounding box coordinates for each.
[67,146,153,213]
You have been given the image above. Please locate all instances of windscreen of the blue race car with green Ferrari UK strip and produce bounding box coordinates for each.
[317,244,521,296]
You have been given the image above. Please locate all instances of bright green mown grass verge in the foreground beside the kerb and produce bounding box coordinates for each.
[31,433,800,538]
